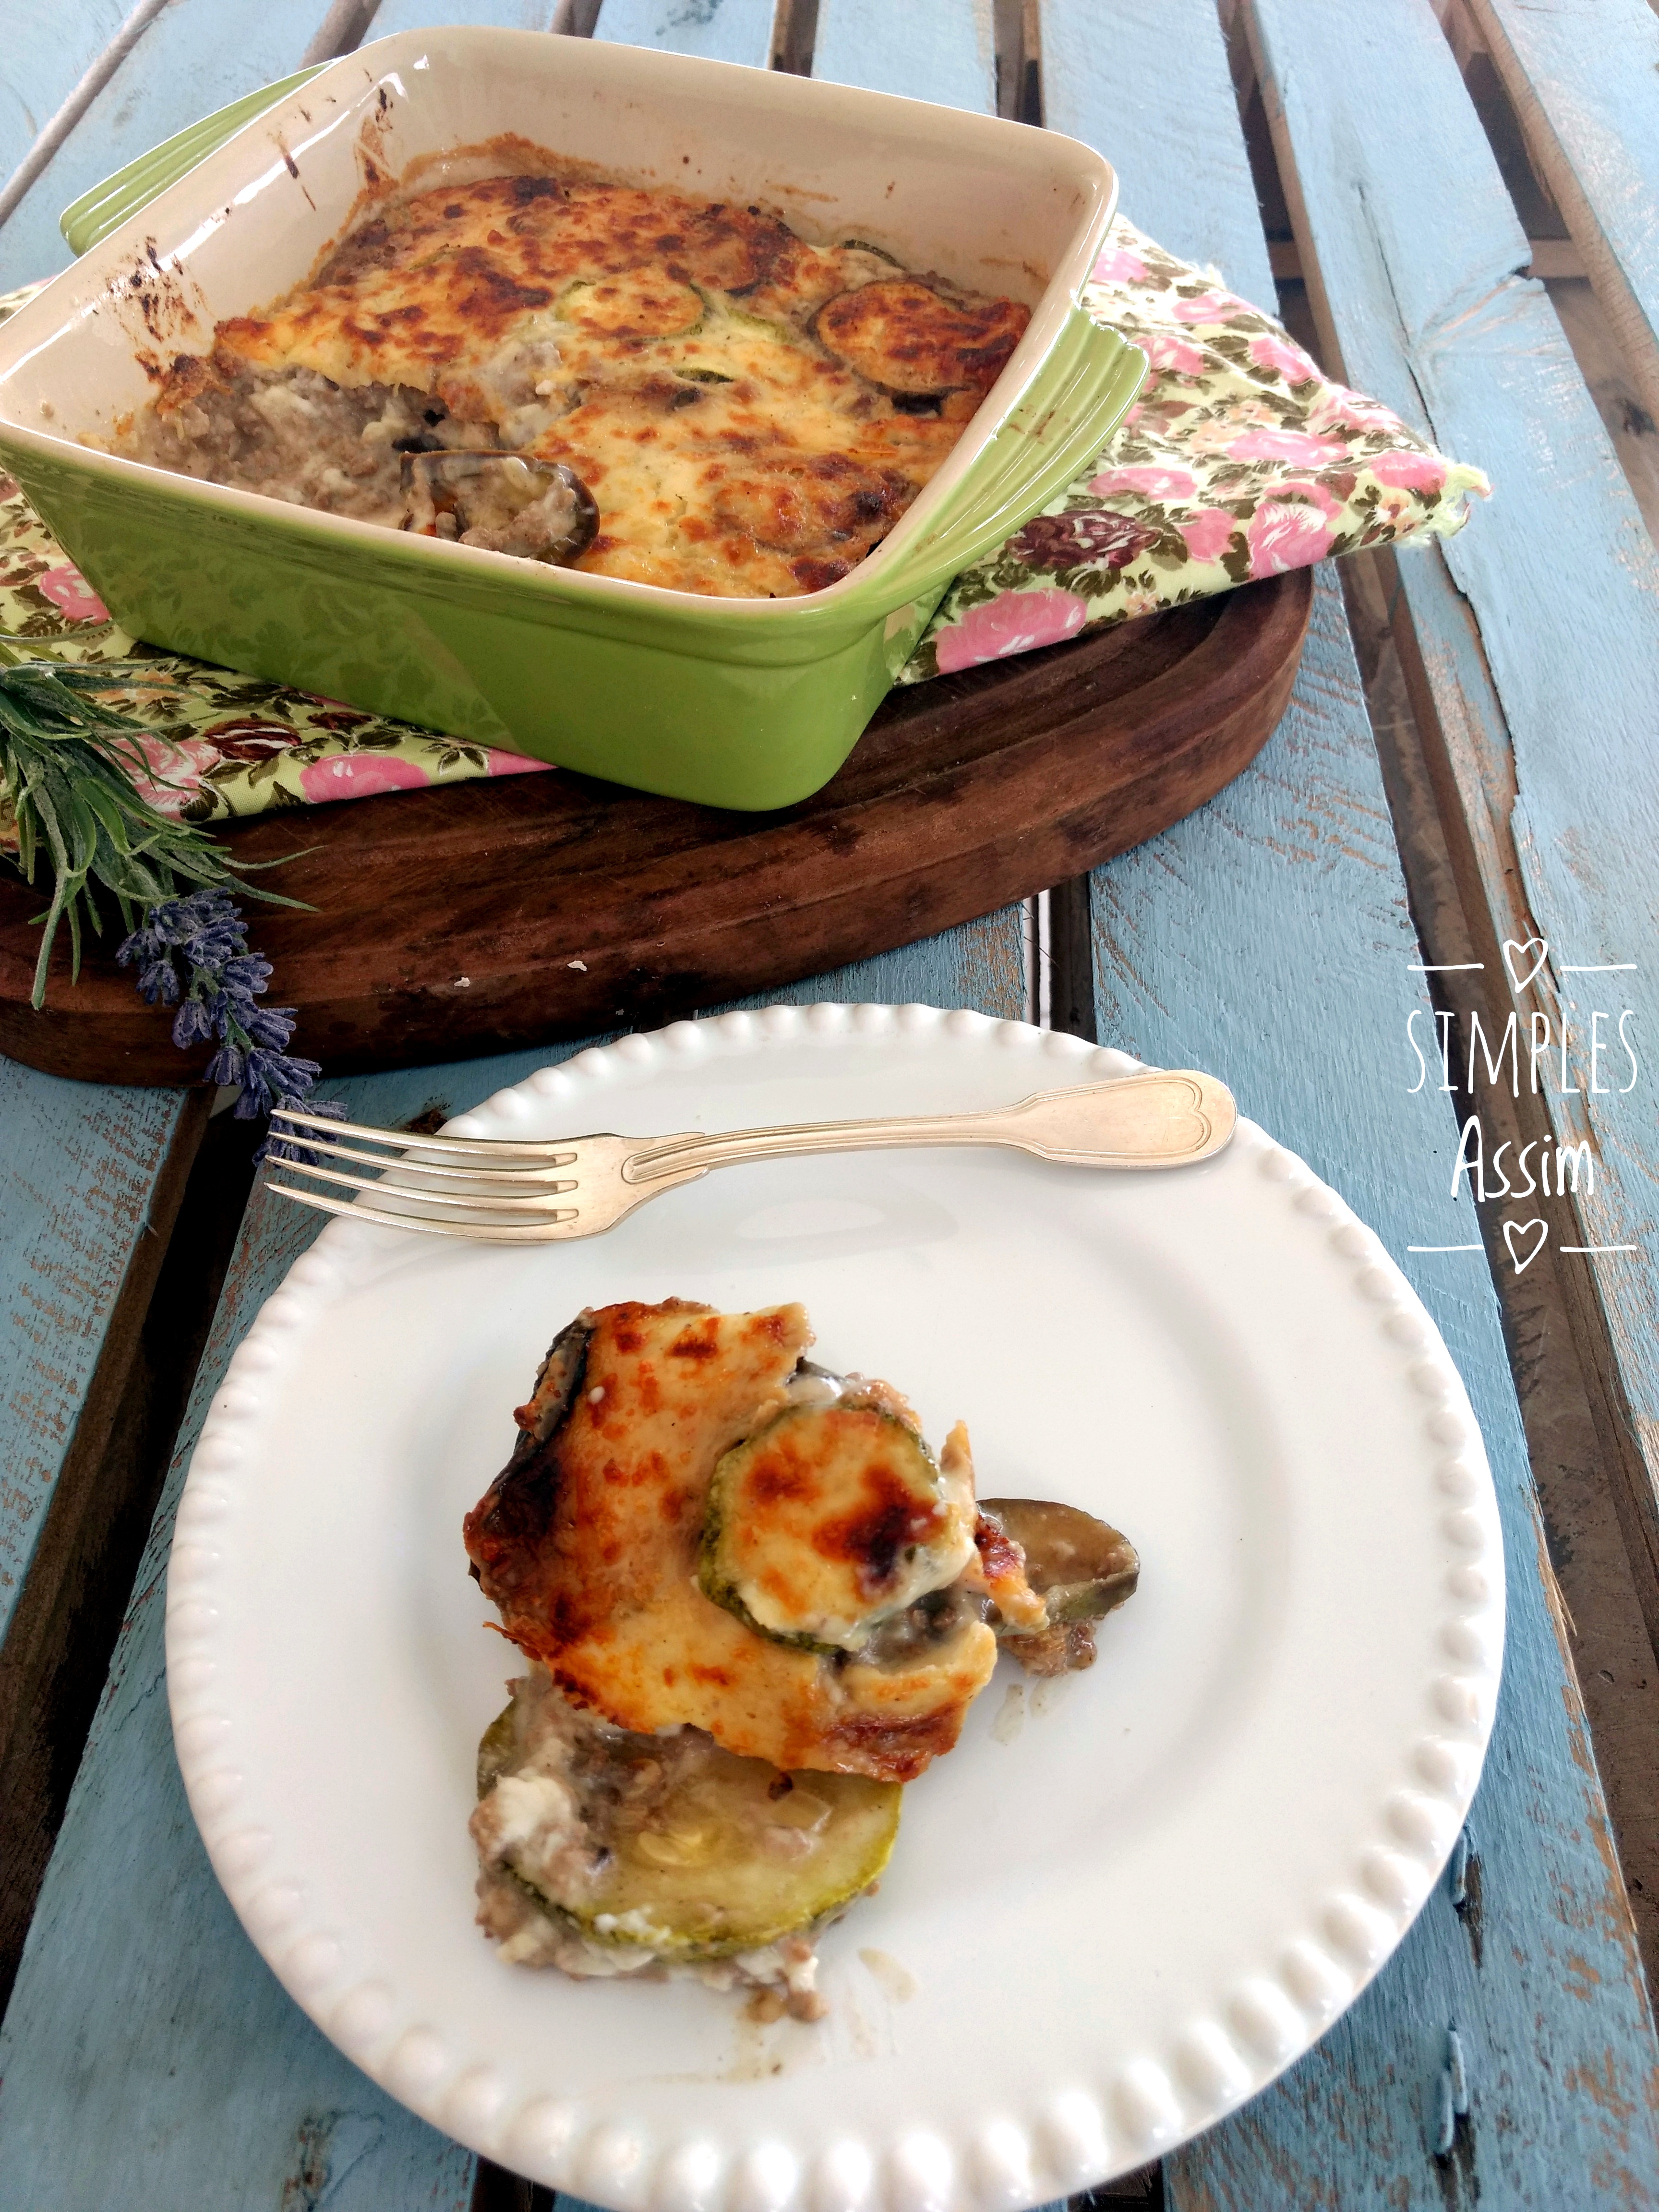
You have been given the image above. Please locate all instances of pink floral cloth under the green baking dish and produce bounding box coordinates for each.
[0,217,1491,843]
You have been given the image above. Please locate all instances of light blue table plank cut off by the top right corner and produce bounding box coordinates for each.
[1469,0,1659,445]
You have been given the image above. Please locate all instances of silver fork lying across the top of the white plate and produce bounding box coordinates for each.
[265,1069,1237,1243]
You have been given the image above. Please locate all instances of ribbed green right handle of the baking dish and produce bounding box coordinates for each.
[869,305,1146,606]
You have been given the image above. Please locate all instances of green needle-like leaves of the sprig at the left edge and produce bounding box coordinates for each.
[0,646,301,1007]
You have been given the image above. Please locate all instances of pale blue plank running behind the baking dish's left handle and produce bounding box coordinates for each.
[0,0,340,290]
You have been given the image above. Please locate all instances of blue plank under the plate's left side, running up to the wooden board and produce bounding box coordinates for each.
[0,909,1024,2212]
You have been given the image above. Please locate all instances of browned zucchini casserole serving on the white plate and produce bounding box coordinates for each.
[467,1298,1139,2020]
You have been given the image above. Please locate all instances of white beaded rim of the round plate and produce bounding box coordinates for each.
[166,1004,1504,2212]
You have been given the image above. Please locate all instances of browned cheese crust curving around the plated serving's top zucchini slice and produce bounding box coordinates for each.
[465,1298,996,1780]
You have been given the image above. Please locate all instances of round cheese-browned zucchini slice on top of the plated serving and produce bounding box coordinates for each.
[697,1396,975,1652]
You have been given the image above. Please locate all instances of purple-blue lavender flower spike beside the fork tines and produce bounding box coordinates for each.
[115,889,345,1161]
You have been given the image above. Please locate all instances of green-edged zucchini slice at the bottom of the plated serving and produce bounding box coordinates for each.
[473,1670,902,1964]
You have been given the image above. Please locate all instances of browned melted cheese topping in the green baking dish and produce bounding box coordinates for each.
[132,175,1026,597]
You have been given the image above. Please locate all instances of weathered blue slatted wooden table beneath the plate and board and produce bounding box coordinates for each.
[0,0,1659,2212]
